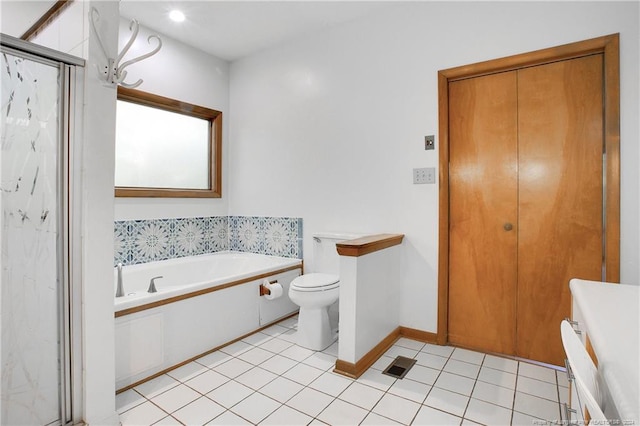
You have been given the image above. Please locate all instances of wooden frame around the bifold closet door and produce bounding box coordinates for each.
[437,34,620,345]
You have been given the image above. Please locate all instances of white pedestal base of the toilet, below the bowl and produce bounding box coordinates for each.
[296,307,338,351]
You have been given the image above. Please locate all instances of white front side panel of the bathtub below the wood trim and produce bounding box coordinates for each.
[115,266,302,390]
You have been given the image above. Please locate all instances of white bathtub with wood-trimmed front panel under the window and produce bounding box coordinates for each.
[114,252,302,389]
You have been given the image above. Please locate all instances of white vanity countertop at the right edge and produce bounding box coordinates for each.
[570,279,640,424]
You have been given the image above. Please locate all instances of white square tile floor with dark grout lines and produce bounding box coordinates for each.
[116,317,568,426]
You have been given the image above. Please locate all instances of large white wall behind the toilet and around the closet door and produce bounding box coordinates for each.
[228,2,640,332]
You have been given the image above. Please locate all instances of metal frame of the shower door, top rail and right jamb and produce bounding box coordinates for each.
[0,34,85,425]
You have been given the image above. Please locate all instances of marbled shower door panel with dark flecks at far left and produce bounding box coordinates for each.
[0,41,69,425]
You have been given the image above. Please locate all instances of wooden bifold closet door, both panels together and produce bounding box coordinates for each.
[448,54,603,365]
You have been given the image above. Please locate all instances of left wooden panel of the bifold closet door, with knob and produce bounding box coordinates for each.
[449,72,517,354]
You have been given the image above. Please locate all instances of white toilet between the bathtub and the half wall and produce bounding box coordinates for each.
[289,234,357,351]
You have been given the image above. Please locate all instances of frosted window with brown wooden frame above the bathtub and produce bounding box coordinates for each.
[115,87,222,198]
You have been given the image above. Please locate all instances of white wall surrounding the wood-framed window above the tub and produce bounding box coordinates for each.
[115,18,229,220]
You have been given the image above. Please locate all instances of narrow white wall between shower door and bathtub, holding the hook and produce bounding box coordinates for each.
[33,1,119,425]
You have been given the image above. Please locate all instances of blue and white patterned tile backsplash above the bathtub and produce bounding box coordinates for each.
[114,216,302,266]
